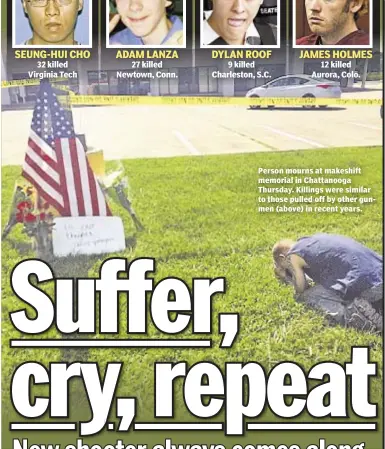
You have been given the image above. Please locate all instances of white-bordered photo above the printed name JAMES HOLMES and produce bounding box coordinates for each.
[293,0,372,48]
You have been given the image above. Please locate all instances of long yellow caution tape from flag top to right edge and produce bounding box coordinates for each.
[56,95,382,106]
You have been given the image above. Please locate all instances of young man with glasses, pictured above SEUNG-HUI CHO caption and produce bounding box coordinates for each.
[23,0,83,46]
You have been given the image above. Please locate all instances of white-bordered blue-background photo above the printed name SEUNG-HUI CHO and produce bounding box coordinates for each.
[12,0,92,48]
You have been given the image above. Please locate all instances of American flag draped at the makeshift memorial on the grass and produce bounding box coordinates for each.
[22,81,111,217]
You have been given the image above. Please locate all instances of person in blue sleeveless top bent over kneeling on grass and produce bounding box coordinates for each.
[273,233,383,331]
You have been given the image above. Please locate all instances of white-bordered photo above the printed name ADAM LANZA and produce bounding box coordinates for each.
[106,0,186,48]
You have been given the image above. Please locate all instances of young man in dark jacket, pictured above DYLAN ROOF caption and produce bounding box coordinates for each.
[202,0,276,46]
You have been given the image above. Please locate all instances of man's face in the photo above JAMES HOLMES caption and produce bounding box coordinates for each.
[305,0,359,36]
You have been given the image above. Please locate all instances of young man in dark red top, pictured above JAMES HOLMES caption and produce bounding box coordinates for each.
[296,0,370,46]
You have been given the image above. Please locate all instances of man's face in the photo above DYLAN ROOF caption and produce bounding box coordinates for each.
[210,0,263,44]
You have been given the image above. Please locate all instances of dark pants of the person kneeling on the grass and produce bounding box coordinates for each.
[296,285,384,333]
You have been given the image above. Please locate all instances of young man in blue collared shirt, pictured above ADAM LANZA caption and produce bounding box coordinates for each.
[109,0,184,46]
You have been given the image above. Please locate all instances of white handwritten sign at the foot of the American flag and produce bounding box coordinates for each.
[52,217,126,257]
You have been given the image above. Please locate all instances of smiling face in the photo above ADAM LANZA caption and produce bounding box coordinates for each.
[116,0,172,40]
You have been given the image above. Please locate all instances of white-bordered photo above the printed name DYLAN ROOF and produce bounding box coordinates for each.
[200,0,280,48]
